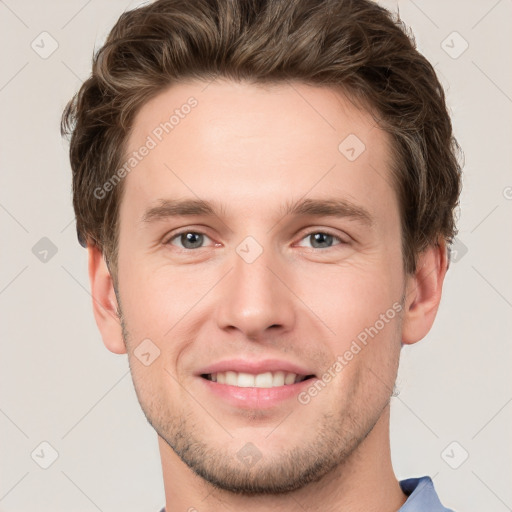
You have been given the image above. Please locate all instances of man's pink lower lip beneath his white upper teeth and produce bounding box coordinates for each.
[199,377,316,409]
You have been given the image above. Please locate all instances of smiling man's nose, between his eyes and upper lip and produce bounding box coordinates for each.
[217,243,296,341]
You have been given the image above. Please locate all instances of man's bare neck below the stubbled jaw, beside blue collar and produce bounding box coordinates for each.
[158,405,406,512]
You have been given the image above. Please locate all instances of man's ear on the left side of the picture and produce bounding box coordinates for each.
[87,245,126,354]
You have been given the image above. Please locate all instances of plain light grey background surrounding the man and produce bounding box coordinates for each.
[0,0,512,512]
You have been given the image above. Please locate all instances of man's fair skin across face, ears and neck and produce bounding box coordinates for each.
[88,80,447,512]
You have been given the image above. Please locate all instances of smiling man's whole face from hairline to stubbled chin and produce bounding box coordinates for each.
[118,81,405,493]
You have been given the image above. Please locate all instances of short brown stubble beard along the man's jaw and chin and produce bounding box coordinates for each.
[120,314,389,496]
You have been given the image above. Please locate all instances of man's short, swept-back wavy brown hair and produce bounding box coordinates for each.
[61,0,461,278]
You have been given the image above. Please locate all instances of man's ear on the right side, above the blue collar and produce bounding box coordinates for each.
[402,239,449,345]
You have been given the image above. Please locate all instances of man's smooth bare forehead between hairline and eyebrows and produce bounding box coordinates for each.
[121,80,396,228]
